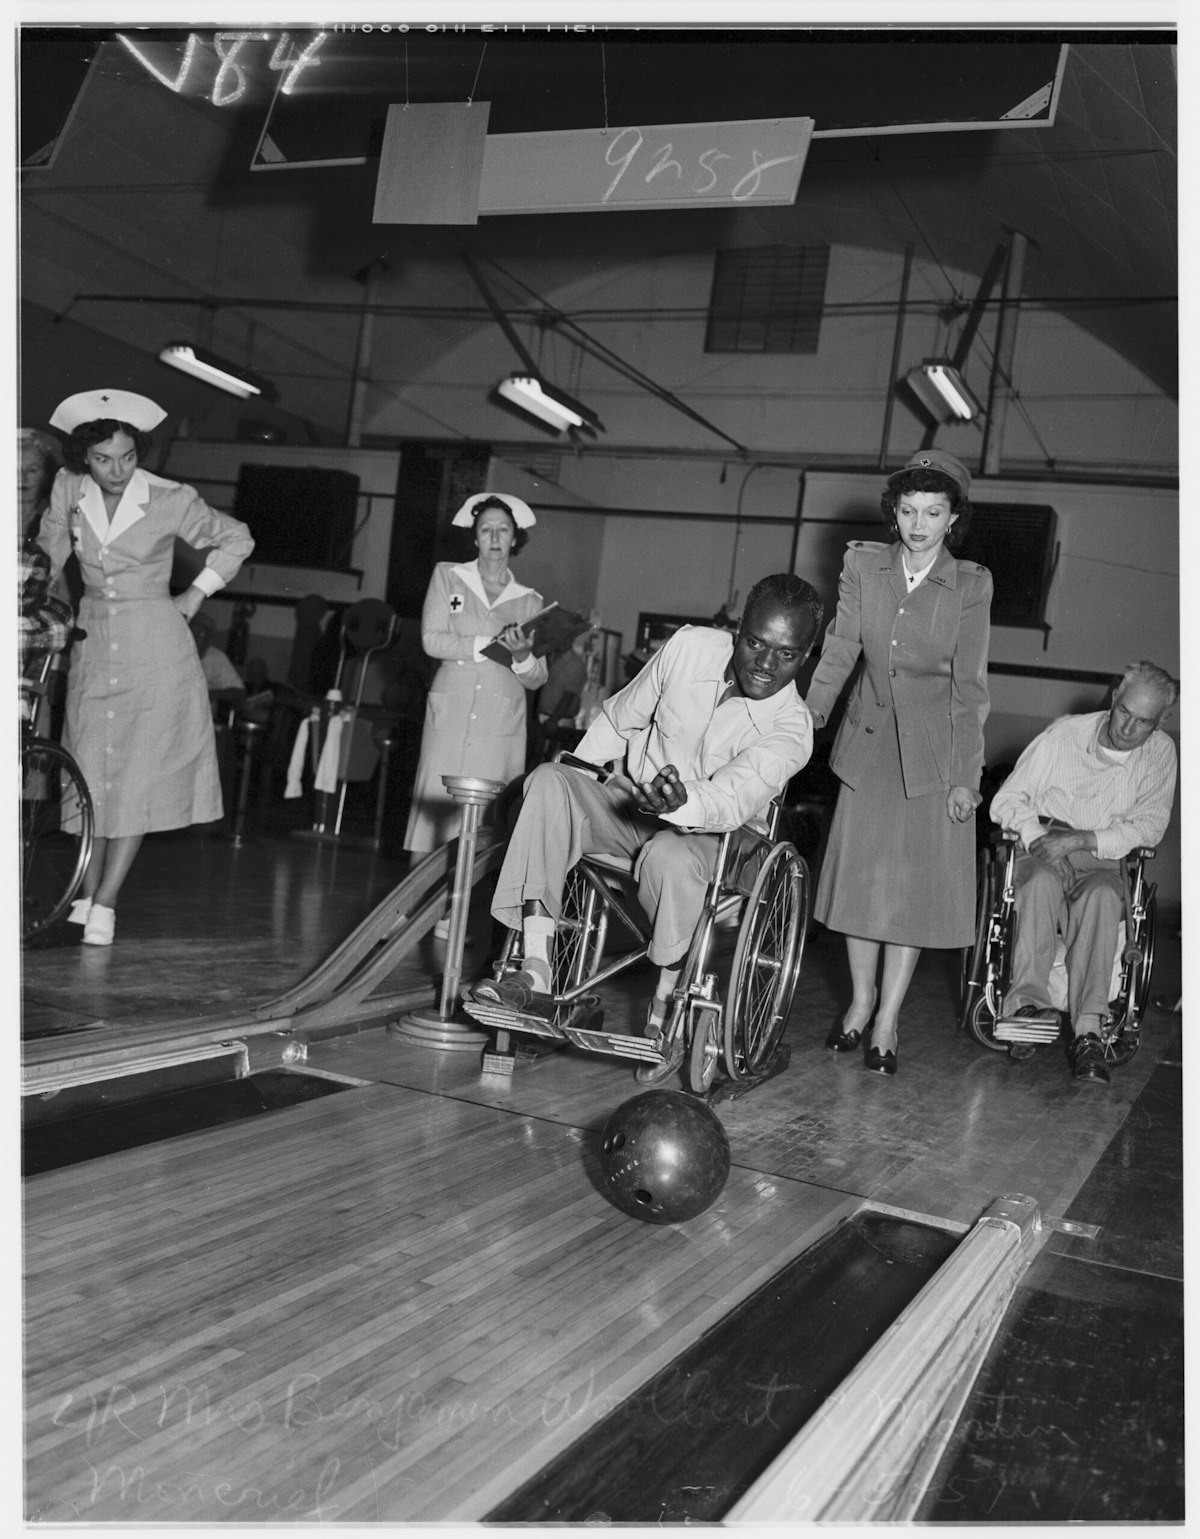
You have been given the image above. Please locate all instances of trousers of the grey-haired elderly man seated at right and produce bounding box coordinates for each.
[1005,850,1125,1022]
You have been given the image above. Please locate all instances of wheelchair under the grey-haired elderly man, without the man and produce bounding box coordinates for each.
[958,830,1158,1067]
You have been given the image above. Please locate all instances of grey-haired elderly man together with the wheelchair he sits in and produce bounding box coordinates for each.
[968,662,1178,1083]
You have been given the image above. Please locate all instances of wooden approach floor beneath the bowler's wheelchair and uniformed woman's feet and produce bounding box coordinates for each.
[300,934,1171,1225]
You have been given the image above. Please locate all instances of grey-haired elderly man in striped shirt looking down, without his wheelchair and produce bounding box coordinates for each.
[991,662,1178,1083]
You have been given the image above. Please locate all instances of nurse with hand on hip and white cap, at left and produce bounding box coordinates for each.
[38,389,254,946]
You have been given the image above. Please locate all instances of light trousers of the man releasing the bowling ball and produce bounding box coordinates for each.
[492,763,720,966]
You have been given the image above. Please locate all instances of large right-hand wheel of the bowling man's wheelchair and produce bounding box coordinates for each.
[725,843,812,1082]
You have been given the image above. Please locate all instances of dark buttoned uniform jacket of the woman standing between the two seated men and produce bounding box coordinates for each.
[808,540,992,797]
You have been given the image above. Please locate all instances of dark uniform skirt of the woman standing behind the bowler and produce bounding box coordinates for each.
[812,717,975,946]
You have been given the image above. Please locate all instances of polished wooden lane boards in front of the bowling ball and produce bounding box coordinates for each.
[25,1077,855,1522]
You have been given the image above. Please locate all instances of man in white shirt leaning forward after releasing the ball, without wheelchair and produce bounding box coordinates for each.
[471,573,823,1083]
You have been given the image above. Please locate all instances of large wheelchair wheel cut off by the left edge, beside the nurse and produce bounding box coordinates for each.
[22,737,94,940]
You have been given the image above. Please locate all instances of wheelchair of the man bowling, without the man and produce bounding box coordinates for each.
[463,756,812,1096]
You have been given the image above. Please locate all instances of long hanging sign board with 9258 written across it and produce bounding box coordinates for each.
[478,117,812,214]
